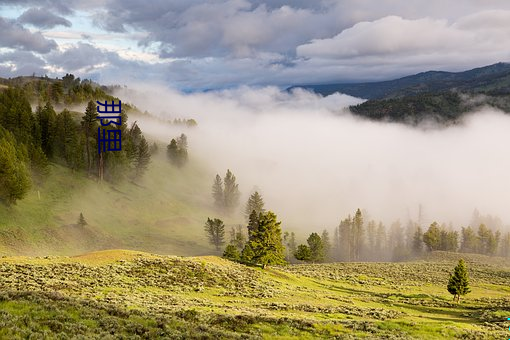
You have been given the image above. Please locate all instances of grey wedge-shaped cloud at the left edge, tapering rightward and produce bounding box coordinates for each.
[0,17,57,53]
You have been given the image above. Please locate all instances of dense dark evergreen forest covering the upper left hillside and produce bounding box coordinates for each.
[0,74,150,204]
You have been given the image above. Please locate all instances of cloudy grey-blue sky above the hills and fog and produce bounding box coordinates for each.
[0,0,510,91]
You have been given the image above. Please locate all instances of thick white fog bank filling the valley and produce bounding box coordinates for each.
[115,86,510,230]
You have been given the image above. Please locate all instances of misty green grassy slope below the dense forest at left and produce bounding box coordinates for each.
[0,153,228,255]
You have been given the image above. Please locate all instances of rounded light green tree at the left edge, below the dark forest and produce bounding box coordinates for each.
[0,128,31,205]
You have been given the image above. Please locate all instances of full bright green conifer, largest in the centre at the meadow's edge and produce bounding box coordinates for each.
[247,211,285,268]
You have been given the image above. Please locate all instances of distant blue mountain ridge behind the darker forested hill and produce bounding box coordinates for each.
[289,63,510,99]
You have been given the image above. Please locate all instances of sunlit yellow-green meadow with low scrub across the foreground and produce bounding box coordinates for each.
[0,250,510,339]
